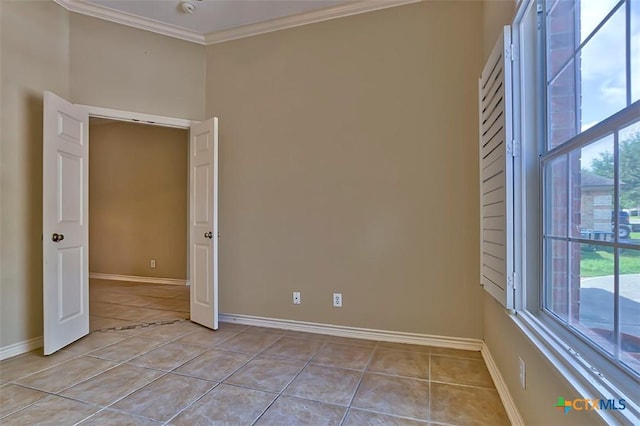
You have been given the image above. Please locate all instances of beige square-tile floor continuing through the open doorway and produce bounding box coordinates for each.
[0,282,509,426]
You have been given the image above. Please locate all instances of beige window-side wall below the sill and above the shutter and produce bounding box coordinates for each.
[483,0,602,426]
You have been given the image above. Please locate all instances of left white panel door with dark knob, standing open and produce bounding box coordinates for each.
[42,92,89,355]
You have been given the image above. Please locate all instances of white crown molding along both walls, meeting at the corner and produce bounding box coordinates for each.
[54,0,423,45]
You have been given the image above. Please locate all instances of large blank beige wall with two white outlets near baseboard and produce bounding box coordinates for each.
[207,1,482,338]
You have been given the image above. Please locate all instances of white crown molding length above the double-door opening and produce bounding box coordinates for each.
[53,0,204,44]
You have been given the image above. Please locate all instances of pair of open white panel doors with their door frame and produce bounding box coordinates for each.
[42,92,219,355]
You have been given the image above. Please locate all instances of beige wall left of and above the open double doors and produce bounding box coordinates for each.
[0,0,205,348]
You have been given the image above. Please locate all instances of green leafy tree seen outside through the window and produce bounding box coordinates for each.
[591,132,640,209]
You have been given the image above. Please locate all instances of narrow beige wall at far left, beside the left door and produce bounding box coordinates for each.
[0,0,69,347]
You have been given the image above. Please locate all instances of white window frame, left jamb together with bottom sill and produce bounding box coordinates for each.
[510,0,640,424]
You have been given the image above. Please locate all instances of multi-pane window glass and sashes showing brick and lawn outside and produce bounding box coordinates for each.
[540,0,640,379]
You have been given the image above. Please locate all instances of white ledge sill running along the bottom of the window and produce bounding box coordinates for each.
[509,310,640,425]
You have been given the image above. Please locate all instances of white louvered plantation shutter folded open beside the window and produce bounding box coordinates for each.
[479,26,514,309]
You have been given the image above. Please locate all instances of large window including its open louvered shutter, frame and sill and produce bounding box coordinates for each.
[492,0,640,424]
